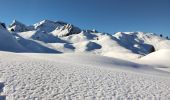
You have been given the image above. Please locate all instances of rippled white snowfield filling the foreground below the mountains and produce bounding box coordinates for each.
[0,52,170,100]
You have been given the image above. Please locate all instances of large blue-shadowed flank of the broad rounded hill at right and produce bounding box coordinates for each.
[113,32,155,55]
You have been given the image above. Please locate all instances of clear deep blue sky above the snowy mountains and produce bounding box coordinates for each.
[0,0,170,36]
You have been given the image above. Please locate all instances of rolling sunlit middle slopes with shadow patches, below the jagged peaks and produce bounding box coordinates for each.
[17,31,141,59]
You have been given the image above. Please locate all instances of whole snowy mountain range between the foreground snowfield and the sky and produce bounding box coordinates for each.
[0,20,170,59]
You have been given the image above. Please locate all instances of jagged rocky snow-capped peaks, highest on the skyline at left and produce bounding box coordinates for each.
[8,20,81,34]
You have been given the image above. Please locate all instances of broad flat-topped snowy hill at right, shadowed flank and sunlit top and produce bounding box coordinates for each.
[113,32,170,54]
